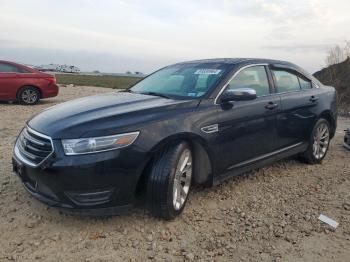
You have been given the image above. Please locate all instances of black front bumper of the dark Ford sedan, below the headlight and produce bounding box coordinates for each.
[12,137,147,215]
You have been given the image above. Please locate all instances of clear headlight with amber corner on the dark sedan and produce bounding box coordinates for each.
[62,132,140,155]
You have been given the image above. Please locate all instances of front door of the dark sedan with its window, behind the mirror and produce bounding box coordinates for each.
[212,65,280,173]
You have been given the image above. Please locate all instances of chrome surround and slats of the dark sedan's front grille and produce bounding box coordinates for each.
[14,126,54,167]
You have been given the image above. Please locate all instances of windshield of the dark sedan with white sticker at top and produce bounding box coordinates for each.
[130,63,228,98]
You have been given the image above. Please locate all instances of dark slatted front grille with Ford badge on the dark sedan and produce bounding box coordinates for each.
[15,127,53,165]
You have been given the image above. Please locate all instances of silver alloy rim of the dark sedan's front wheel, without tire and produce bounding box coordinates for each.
[173,149,192,210]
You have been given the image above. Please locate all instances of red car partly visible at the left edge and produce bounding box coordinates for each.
[0,60,58,105]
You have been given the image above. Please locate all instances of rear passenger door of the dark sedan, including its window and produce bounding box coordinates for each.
[271,66,318,148]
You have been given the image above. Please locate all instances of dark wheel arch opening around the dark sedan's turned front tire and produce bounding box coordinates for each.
[135,133,213,198]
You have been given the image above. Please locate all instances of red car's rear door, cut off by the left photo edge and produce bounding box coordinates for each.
[0,63,20,100]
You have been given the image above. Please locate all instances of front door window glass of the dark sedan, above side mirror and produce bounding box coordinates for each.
[228,66,270,96]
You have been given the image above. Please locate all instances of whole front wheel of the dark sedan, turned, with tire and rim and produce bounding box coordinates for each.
[147,142,193,220]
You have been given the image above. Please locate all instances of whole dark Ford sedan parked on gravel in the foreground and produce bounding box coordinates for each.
[13,59,337,219]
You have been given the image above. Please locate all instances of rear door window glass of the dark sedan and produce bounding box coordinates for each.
[272,70,300,93]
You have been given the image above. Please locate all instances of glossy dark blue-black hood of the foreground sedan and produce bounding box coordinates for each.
[27,92,198,139]
